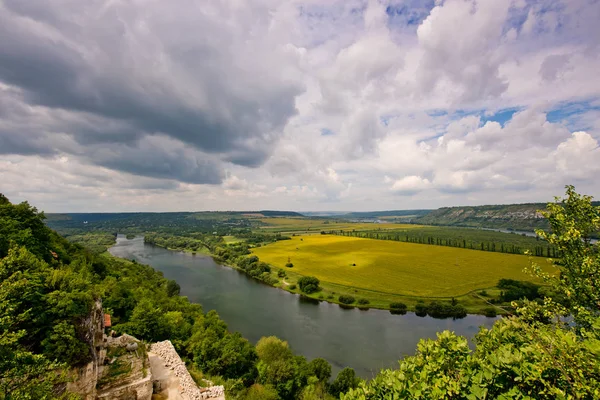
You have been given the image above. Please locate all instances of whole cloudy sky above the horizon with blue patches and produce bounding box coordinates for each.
[0,0,600,212]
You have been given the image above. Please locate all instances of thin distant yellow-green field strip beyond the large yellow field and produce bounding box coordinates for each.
[259,217,421,233]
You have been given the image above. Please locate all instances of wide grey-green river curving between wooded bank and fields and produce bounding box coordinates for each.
[110,235,495,378]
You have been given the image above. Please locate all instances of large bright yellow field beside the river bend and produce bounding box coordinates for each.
[253,235,552,297]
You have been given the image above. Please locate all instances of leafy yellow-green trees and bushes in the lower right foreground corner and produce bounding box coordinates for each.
[342,187,600,400]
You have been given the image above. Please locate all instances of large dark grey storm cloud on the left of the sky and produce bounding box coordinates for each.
[0,0,302,183]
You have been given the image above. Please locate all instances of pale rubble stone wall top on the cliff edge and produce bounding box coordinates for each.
[150,340,225,400]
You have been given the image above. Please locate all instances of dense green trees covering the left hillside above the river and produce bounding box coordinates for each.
[0,196,356,400]
